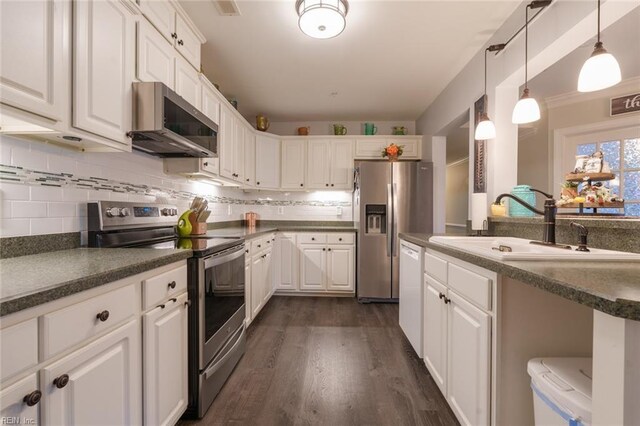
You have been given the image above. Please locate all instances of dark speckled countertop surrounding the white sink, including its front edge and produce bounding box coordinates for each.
[400,233,640,321]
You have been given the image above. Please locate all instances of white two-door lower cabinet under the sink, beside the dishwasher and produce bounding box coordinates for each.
[423,253,496,426]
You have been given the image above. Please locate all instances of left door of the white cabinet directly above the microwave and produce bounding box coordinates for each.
[136,19,176,90]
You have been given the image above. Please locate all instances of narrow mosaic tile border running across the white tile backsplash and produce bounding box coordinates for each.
[0,164,351,207]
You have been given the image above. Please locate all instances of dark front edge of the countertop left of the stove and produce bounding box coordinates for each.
[0,250,192,317]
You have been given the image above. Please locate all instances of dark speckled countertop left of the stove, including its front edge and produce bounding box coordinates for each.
[0,248,192,316]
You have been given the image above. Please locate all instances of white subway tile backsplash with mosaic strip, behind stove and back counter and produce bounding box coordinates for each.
[0,135,352,237]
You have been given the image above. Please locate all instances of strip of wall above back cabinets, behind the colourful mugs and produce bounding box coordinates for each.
[269,120,416,136]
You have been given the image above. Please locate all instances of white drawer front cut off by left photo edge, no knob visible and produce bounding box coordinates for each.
[0,318,38,380]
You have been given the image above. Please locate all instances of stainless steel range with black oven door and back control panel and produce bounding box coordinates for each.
[88,201,245,418]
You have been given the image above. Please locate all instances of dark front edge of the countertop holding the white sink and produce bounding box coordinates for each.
[400,233,640,321]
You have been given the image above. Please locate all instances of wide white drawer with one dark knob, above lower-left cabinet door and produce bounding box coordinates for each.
[41,284,140,361]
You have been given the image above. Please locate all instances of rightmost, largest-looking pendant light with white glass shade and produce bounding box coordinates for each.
[578,0,622,92]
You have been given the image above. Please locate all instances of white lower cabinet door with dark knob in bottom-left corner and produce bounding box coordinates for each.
[0,373,41,425]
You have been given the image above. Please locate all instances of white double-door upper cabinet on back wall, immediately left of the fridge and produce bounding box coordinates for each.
[307,139,353,189]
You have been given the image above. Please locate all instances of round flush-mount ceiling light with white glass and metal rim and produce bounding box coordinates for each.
[296,0,349,38]
